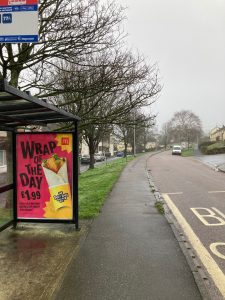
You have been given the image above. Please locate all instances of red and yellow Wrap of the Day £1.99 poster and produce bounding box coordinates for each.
[16,133,73,220]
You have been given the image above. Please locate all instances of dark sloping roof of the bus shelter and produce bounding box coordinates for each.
[0,79,80,130]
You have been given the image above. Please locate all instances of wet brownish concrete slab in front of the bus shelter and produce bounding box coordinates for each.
[0,222,90,300]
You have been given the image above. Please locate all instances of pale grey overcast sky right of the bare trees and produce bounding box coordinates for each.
[117,0,225,132]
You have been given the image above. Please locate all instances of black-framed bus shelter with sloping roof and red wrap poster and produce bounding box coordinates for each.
[0,79,80,231]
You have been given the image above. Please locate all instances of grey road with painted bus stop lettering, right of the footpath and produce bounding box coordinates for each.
[148,152,225,299]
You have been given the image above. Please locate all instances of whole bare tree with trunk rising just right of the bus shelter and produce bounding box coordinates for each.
[55,49,161,168]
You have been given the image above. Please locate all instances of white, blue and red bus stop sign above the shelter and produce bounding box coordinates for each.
[0,0,38,43]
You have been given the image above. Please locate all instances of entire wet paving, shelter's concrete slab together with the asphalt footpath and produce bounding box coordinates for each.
[0,157,214,300]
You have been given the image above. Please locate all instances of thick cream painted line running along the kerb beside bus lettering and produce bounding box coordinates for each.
[163,194,225,297]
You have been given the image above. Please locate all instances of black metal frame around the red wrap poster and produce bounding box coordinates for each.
[13,130,79,229]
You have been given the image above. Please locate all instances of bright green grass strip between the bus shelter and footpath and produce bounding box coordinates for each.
[79,157,134,219]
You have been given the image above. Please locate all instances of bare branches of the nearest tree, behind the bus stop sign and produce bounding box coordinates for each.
[0,0,123,89]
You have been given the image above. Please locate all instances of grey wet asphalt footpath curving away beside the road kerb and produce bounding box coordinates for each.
[55,156,202,300]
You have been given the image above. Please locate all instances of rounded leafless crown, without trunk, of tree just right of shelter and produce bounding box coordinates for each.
[49,48,161,119]
